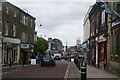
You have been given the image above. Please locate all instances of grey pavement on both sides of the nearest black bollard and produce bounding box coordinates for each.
[65,62,120,80]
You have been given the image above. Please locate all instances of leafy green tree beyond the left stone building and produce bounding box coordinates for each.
[35,37,48,54]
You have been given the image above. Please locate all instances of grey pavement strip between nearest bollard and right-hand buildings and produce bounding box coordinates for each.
[87,65,118,78]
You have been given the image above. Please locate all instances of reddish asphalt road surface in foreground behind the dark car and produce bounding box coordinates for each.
[2,60,68,78]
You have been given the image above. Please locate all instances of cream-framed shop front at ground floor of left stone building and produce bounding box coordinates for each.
[2,37,21,65]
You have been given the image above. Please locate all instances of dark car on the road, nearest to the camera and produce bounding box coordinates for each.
[41,55,55,67]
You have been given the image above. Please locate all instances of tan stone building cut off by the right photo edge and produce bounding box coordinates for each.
[107,2,120,76]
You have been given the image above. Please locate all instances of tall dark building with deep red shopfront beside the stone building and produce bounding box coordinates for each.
[89,2,108,69]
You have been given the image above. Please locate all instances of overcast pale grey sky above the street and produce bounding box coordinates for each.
[7,0,95,46]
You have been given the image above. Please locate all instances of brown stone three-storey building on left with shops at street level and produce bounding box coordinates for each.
[0,2,35,64]
